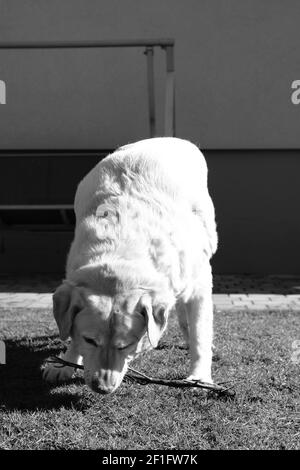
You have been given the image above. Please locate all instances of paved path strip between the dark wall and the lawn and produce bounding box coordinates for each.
[0,275,300,312]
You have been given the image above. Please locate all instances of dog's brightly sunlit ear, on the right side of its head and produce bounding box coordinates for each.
[139,294,167,348]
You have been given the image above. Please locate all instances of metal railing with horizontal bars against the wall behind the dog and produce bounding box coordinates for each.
[0,39,175,215]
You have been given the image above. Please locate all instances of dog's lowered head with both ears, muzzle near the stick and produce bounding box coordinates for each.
[53,282,170,393]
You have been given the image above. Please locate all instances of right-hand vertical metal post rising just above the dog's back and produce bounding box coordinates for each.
[163,45,175,136]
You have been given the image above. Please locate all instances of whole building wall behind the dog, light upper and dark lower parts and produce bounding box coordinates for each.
[0,0,300,273]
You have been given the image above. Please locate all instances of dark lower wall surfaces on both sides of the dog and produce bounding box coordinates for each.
[0,150,300,274]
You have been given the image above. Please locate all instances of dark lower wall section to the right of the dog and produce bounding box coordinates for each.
[205,150,300,274]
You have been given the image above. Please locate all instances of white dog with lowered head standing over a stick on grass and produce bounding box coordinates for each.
[44,137,217,393]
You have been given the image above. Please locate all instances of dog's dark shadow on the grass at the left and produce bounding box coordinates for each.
[0,335,83,411]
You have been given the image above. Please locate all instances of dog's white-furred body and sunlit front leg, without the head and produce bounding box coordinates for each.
[44,138,217,392]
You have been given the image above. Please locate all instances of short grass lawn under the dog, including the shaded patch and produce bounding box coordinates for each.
[0,309,300,450]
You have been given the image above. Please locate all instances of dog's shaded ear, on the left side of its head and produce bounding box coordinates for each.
[53,283,84,341]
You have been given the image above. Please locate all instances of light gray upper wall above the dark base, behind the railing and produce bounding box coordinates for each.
[0,0,300,149]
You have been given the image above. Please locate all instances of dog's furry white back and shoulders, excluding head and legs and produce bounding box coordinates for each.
[67,138,217,285]
